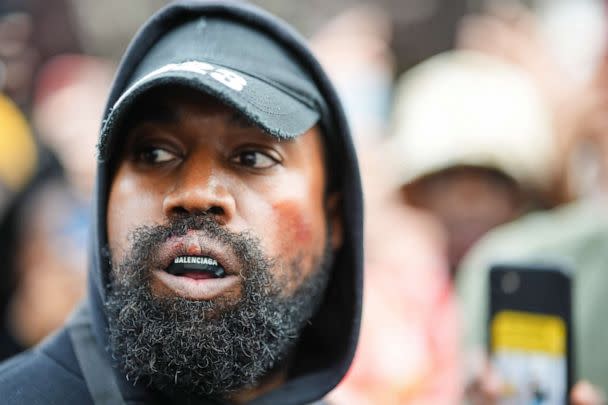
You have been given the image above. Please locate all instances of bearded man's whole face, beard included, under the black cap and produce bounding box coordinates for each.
[107,89,340,394]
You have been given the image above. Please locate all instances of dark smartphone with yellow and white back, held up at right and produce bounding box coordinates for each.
[488,263,573,405]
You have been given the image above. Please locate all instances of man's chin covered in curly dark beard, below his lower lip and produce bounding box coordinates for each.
[106,274,309,396]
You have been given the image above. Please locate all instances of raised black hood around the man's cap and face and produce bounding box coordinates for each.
[88,1,363,404]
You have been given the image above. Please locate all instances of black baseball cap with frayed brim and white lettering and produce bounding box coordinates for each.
[102,17,325,142]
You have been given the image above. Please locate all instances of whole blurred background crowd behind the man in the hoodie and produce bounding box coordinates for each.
[0,0,608,405]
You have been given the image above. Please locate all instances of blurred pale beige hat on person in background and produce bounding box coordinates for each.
[387,51,556,190]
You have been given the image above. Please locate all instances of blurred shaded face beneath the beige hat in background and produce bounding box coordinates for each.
[406,167,521,269]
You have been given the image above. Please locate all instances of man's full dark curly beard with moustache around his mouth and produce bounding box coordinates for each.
[105,216,332,397]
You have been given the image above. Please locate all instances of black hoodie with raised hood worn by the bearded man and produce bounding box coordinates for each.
[0,1,363,405]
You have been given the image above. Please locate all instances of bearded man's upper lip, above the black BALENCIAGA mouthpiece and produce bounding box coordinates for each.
[157,231,240,275]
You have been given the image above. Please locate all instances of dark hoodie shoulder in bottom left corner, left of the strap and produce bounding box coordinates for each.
[0,330,93,405]
